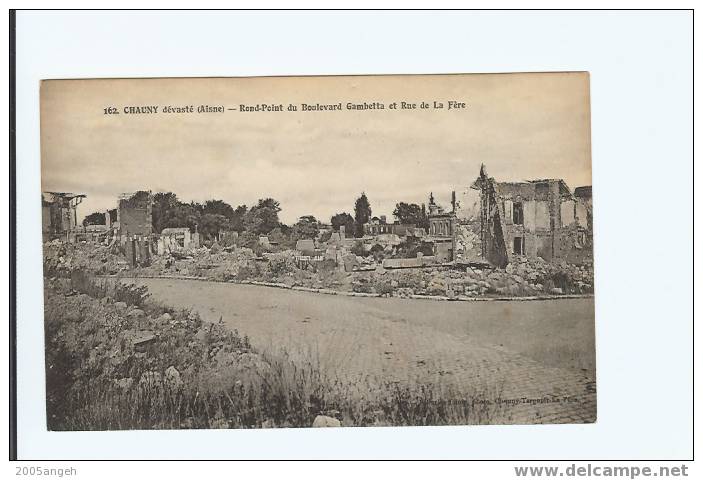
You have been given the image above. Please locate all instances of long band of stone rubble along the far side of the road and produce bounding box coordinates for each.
[44,238,593,298]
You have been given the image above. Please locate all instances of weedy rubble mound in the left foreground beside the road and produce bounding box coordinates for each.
[45,279,278,430]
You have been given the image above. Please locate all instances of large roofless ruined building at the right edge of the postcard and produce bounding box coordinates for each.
[471,165,593,267]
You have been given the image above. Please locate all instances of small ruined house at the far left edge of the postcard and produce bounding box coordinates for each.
[42,192,86,242]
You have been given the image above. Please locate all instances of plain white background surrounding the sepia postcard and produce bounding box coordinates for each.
[11,11,693,459]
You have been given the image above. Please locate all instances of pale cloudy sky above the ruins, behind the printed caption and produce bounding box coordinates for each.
[41,73,591,223]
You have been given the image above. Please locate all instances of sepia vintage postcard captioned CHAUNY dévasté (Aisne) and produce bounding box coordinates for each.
[37,72,596,430]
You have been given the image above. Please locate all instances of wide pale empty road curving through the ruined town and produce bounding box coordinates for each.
[131,279,596,423]
